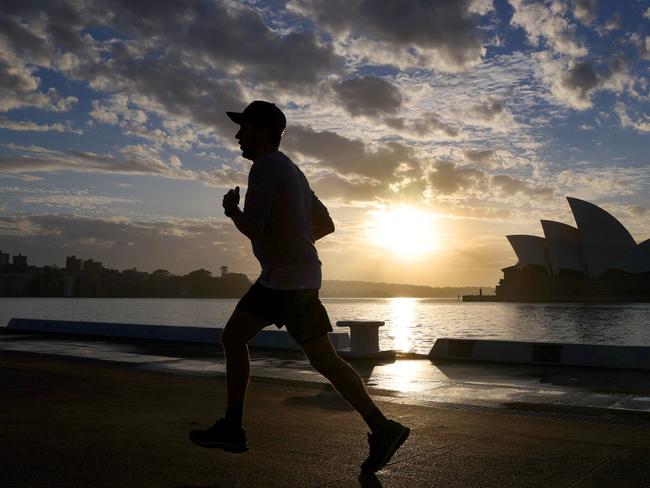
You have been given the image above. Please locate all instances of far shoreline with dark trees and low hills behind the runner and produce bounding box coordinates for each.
[0,251,494,298]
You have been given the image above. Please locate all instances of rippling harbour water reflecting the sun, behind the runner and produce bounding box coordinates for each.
[0,297,650,353]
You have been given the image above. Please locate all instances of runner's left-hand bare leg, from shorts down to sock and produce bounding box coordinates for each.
[221,310,268,408]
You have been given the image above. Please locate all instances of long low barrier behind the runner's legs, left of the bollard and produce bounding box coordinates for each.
[7,318,350,349]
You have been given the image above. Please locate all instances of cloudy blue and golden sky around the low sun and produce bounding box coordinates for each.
[0,0,650,286]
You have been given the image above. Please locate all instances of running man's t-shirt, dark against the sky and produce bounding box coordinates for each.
[244,151,331,290]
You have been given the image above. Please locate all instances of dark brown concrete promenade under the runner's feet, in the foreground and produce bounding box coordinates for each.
[0,338,650,488]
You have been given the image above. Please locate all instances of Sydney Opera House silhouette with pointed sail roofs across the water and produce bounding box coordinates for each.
[496,197,650,302]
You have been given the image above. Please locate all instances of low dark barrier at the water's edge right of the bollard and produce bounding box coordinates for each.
[428,338,650,369]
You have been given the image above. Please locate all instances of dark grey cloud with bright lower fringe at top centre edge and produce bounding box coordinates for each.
[287,0,489,71]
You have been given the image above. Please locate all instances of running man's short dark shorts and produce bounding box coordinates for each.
[235,281,332,345]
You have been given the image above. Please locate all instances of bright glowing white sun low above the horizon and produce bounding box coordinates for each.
[367,207,440,259]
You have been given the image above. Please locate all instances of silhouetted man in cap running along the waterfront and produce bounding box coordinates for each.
[190,100,410,473]
